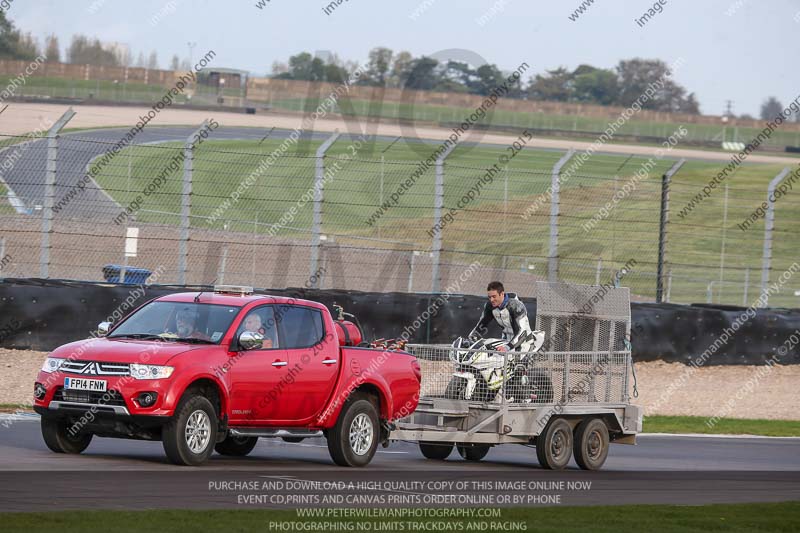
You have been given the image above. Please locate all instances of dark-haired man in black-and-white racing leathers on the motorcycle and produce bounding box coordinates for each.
[469,281,531,351]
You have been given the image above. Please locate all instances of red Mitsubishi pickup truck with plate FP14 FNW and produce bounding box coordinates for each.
[34,287,421,466]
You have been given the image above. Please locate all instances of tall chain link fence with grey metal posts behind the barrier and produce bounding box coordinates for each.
[0,114,800,307]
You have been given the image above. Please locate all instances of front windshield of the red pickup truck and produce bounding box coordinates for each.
[108,302,240,344]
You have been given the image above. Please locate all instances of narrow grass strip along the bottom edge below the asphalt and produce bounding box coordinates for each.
[0,502,800,533]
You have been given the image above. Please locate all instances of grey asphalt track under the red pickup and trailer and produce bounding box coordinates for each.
[0,416,800,511]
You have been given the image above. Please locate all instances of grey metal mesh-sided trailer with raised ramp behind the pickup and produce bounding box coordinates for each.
[390,282,642,470]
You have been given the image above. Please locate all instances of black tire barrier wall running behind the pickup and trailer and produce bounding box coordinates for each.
[0,279,800,365]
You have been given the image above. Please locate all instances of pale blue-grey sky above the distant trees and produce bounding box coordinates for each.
[7,0,800,117]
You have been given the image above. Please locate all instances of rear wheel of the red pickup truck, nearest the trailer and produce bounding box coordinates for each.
[327,396,380,467]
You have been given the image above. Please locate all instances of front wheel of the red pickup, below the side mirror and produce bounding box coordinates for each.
[162,395,218,466]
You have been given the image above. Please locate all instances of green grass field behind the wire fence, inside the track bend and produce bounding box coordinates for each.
[97,137,800,307]
